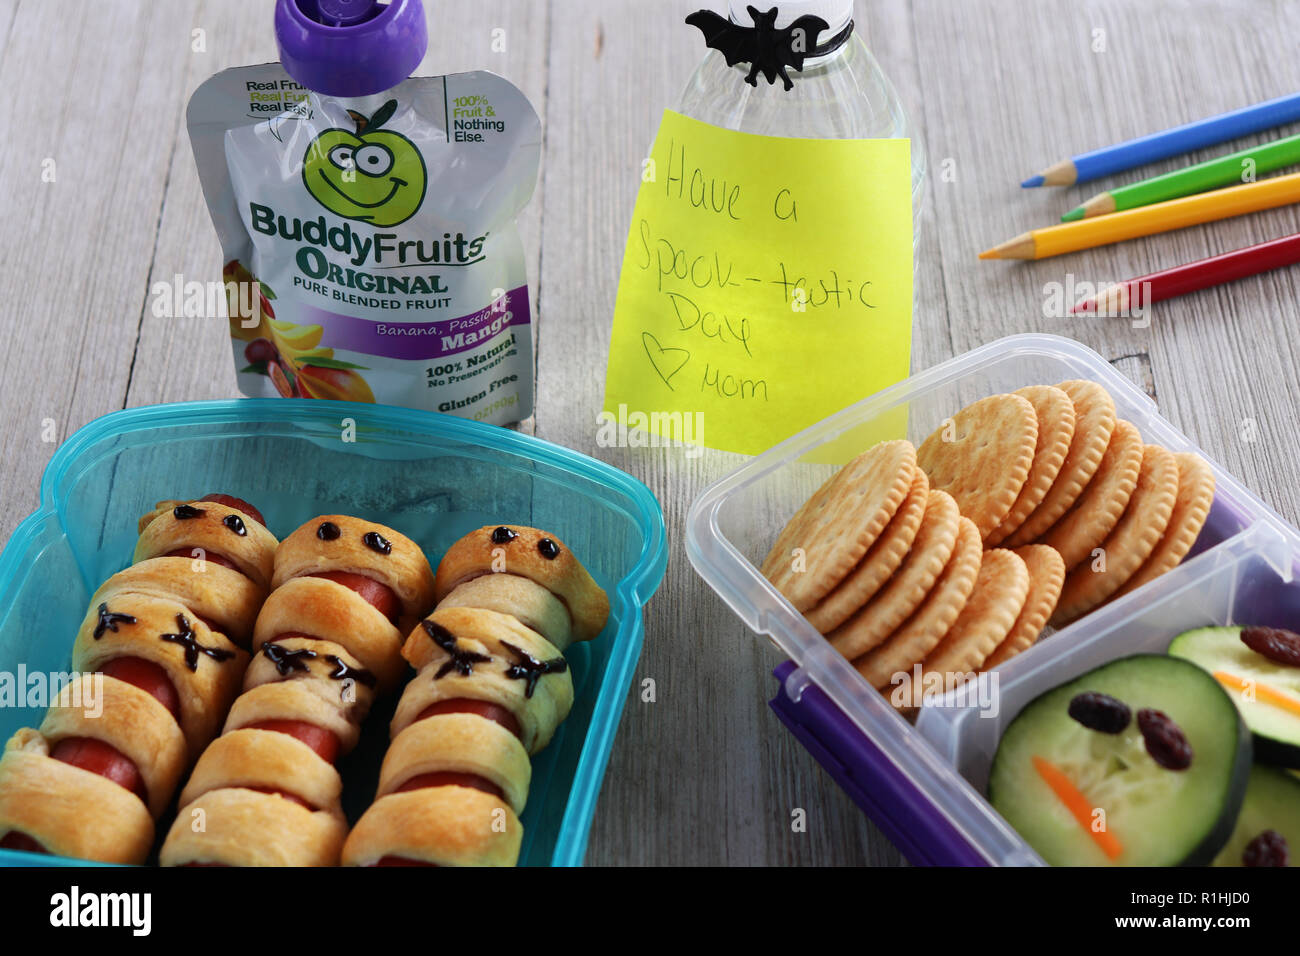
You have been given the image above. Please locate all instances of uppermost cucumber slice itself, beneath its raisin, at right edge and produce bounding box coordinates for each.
[1169,627,1300,767]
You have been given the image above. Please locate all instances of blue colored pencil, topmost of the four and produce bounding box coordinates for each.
[1021,94,1300,189]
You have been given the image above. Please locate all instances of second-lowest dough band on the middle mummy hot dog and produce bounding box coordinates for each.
[179,728,343,812]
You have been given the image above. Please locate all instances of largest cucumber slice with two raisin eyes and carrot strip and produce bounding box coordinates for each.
[988,654,1251,866]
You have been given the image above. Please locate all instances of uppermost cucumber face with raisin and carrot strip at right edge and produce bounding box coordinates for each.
[1169,627,1300,767]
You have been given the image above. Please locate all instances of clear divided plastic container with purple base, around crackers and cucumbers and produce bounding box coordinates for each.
[686,334,1300,865]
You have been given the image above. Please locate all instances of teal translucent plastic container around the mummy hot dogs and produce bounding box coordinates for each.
[0,398,667,866]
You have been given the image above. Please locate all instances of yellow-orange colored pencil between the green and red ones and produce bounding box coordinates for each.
[979,173,1300,259]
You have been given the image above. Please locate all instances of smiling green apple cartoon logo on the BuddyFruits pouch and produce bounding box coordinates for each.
[303,100,428,226]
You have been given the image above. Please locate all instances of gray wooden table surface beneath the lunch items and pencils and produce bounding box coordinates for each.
[0,0,1300,865]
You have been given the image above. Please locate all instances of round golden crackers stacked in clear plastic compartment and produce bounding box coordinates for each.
[762,381,1214,689]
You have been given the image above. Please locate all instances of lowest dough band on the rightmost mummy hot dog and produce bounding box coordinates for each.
[343,787,524,866]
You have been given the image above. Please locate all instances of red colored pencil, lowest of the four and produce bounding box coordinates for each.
[1070,233,1300,315]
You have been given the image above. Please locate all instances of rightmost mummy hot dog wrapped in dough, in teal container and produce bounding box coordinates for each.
[343,525,610,866]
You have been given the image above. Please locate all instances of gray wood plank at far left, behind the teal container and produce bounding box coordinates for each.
[0,0,200,537]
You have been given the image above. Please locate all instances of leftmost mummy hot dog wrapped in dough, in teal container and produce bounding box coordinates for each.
[0,496,277,864]
